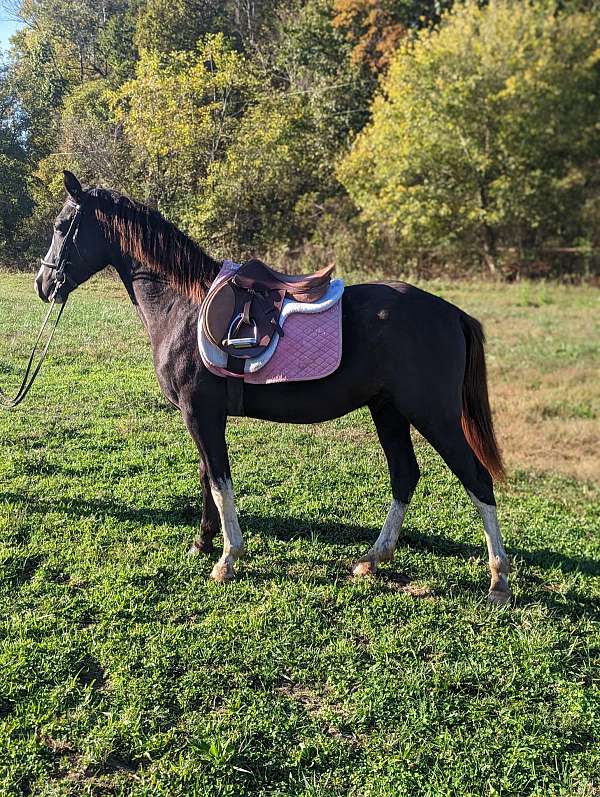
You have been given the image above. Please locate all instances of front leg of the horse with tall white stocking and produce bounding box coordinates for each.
[182,405,244,581]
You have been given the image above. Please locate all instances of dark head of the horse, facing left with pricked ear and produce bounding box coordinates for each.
[35,171,108,303]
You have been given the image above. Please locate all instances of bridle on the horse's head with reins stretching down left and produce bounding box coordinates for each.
[0,197,81,409]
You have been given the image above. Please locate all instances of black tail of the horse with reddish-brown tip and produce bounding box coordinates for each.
[461,313,506,481]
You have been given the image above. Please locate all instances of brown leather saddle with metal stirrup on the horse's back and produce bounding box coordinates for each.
[202,260,334,373]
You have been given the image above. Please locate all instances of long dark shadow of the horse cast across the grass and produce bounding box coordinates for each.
[0,492,600,618]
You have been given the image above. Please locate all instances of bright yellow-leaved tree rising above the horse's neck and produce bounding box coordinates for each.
[113,34,257,218]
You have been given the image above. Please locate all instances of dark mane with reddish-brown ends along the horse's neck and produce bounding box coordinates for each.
[90,188,221,302]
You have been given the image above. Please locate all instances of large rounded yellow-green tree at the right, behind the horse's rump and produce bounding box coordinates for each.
[338,0,600,269]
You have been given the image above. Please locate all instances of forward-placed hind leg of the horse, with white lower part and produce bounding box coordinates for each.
[352,404,419,576]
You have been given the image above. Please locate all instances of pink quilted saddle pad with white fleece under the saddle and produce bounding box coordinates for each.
[198,261,344,385]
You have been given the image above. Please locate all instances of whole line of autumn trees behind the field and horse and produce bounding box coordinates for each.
[0,0,600,274]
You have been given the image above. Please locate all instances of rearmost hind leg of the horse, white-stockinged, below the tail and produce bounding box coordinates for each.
[420,419,511,605]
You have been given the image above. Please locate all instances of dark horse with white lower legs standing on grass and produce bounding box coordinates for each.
[35,172,510,604]
